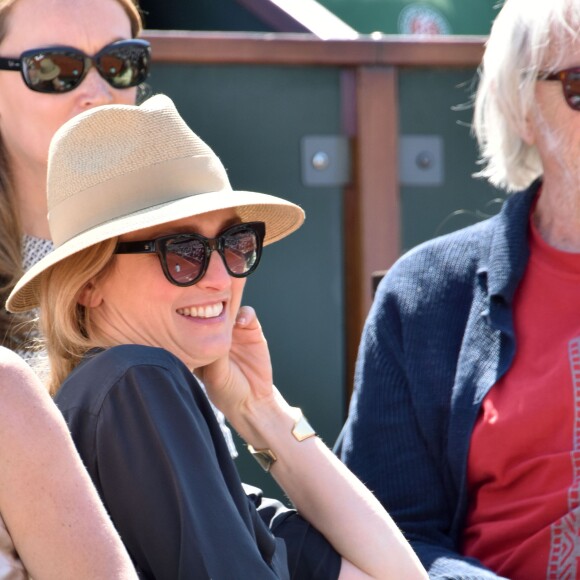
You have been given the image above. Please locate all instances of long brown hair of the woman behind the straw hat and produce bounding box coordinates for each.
[0,0,143,350]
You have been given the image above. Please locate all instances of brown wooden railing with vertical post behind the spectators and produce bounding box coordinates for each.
[144,30,485,394]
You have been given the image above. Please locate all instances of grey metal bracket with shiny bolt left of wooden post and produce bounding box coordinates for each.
[300,135,350,187]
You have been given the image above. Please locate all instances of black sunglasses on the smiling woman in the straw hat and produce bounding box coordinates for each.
[115,222,266,286]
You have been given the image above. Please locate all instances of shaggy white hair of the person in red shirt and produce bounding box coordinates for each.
[473,0,580,191]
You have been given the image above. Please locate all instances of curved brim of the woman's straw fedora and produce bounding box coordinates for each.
[6,190,304,312]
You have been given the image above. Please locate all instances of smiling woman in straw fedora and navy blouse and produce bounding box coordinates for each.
[7,95,426,580]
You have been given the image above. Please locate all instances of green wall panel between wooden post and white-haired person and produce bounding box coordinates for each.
[399,69,505,250]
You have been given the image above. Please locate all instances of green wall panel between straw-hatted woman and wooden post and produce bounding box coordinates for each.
[151,64,345,497]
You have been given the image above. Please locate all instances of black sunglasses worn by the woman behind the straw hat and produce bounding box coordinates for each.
[0,38,151,93]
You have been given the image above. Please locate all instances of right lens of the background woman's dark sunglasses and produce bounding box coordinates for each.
[95,40,150,89]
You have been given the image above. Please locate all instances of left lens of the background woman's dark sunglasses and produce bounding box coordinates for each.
[22,50,85,93]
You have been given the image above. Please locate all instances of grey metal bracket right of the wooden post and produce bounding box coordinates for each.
[399,135,444,186]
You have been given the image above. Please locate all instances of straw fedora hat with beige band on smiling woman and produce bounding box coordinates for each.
[6,95,304,312]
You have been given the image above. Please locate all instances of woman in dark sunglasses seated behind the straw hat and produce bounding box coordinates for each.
[0,0,150,358]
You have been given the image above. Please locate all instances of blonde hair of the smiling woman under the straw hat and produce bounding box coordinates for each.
[39,238,117,396]
